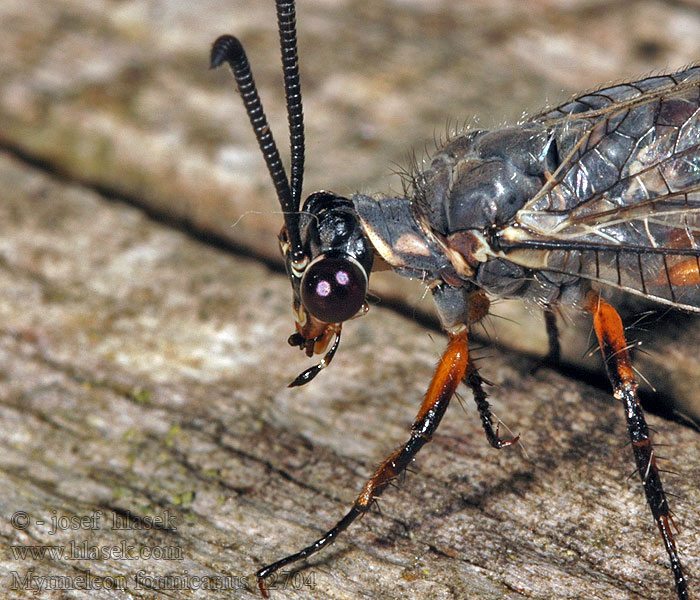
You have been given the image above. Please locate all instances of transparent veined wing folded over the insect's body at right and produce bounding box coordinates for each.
[497,66,700,311]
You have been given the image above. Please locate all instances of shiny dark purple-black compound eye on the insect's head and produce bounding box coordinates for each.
[301,257,367,323]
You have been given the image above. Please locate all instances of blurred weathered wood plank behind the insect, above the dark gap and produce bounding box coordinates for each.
[0,0,700,419]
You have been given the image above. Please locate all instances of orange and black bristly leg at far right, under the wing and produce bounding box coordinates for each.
[585,293,688,600]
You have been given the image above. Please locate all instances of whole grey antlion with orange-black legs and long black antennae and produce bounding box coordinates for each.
[211,0,700,600]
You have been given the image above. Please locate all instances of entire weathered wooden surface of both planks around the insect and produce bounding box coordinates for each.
[0,0,700,599]
